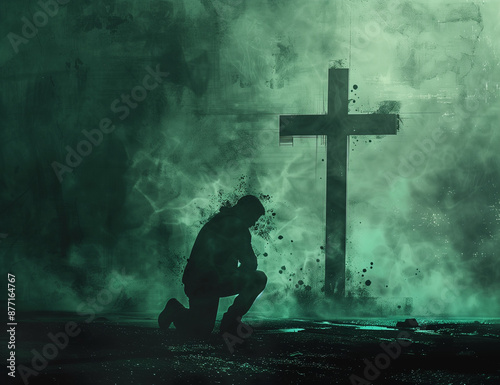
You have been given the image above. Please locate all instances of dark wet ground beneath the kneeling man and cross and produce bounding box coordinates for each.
[2,313,500,385]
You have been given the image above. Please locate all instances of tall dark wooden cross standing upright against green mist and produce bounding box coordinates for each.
[280,68,399,298]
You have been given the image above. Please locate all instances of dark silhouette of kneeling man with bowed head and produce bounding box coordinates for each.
[158,195,267,336]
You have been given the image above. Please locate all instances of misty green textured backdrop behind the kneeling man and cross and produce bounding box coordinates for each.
[0,0,500,317]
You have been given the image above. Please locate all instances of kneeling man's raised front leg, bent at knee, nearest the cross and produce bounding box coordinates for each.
[220,270,267,331]
